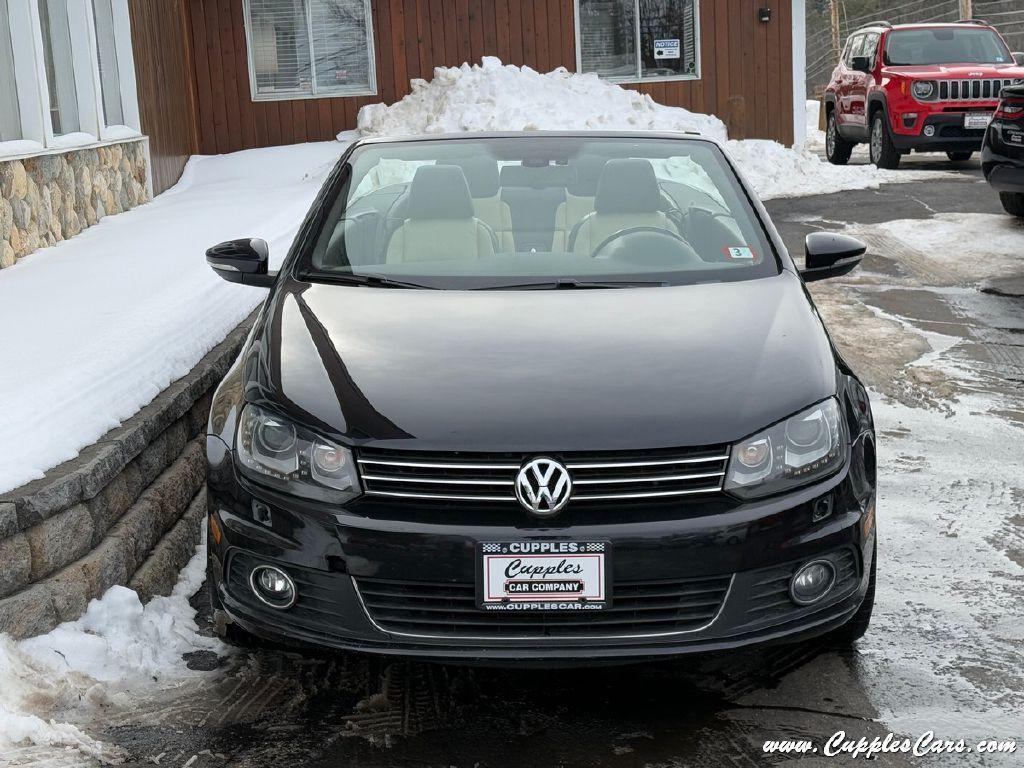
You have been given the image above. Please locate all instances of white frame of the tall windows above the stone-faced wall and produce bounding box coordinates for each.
[0,0,142,154]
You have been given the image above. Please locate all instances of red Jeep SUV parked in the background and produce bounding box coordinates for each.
[824,19,1024,168]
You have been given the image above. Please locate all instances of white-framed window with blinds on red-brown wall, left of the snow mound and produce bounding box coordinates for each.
[245,0,377,101]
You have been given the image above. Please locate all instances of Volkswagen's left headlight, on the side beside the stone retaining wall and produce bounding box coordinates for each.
[236,403,359,504]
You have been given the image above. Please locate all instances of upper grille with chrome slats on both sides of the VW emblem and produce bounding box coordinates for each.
[357,445,729,503]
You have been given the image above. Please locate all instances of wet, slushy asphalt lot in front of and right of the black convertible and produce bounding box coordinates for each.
[8,163,1024,768]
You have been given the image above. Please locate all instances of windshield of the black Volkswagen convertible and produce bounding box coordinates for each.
[299,136,778,289]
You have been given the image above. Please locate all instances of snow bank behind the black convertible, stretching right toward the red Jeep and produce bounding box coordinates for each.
[354,56,950,200]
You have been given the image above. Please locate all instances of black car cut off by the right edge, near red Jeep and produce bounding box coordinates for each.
[981,85,1024,218]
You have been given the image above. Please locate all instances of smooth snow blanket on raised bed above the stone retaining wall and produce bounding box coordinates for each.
[0,141,344,492]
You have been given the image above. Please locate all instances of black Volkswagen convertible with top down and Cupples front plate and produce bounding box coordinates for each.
[207,133,877,664]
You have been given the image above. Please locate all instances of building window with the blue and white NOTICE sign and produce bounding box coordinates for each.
[575,0,700,82]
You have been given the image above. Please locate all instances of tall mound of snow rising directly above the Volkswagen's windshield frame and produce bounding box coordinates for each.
[358,56,726,140]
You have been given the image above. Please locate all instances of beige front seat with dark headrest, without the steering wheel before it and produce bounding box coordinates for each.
[387,165,495,263]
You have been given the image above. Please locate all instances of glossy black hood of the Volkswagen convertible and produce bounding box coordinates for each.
[246,272,837,452]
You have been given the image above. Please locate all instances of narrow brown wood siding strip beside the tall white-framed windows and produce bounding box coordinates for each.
[128,0,200,195]
